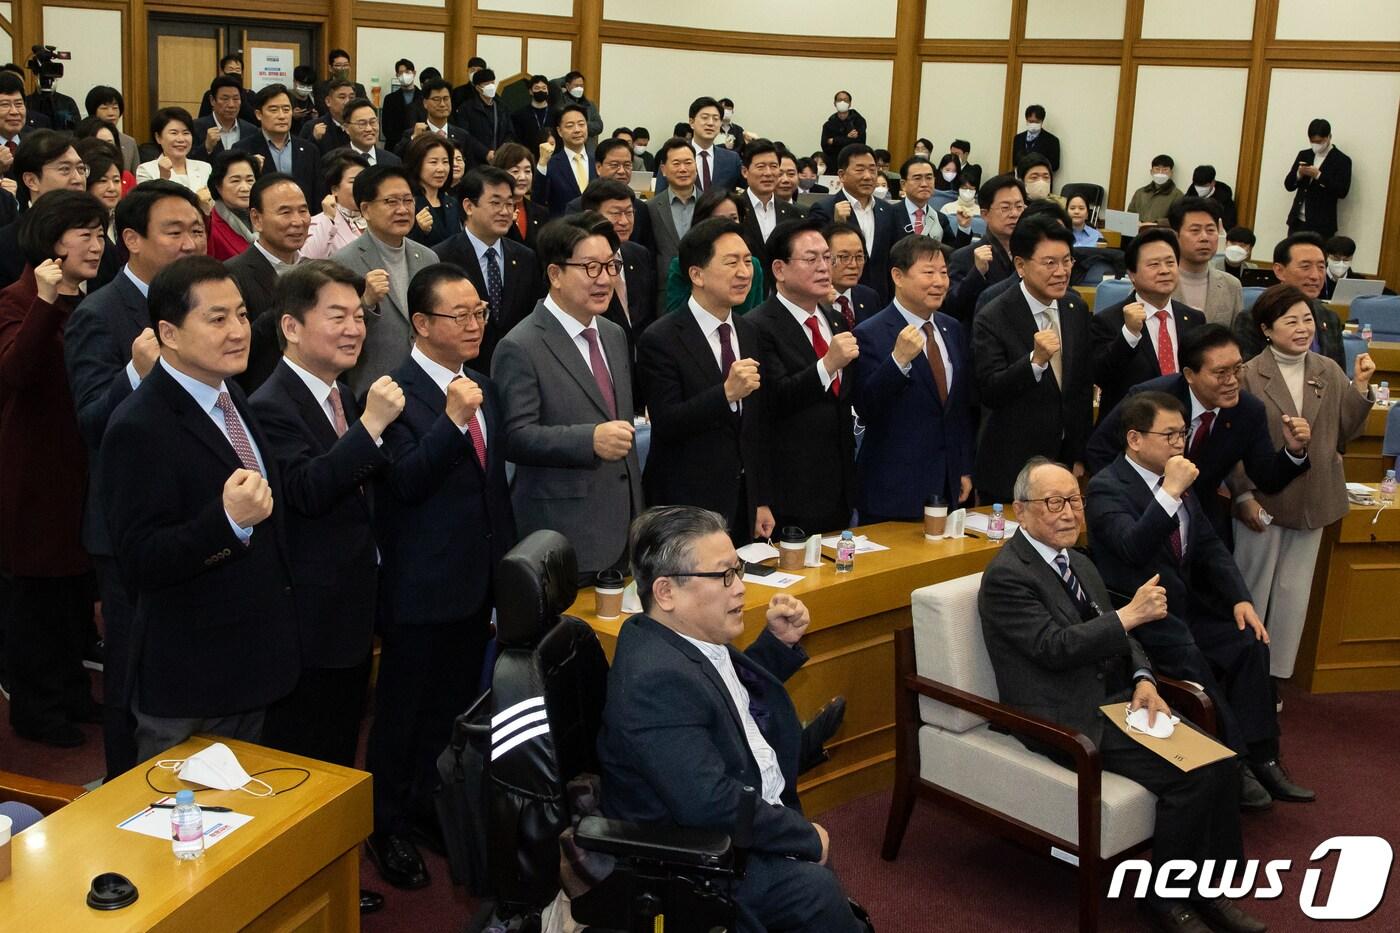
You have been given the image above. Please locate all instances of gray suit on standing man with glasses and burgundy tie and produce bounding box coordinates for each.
[491,301,641,574]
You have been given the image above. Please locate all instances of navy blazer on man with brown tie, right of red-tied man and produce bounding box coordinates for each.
[848,304,976,521]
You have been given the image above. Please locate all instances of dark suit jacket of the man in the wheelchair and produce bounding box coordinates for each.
[598,615,822,862]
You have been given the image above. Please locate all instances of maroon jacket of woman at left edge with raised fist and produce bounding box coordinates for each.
[0,266,91,577]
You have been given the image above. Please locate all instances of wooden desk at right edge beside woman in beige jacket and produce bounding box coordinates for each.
[1294,487,1400,693]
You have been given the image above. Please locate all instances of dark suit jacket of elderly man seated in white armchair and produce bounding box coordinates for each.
[977,532,1151,751]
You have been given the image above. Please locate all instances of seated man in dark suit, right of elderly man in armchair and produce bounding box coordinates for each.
[1085,392,1315,808]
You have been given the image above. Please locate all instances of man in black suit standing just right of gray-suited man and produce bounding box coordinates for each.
[637,217,774,545]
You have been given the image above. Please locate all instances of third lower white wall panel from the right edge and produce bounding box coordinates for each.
[1007,64,1119,191]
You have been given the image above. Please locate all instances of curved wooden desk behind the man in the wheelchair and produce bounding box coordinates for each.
[570,523,1000,815]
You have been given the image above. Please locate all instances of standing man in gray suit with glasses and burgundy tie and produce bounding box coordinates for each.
[491,214,641,583]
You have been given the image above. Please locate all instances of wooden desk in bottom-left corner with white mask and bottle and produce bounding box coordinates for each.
[0,735,372,933]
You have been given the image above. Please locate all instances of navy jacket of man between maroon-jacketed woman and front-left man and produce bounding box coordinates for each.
[63,273,151,556]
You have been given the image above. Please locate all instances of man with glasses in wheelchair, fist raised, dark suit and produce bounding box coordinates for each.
[598,507,861,933]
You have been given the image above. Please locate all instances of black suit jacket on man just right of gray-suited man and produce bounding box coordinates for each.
[637,308,773,542]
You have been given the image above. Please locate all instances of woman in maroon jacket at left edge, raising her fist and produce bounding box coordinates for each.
[0,191,106,748]
